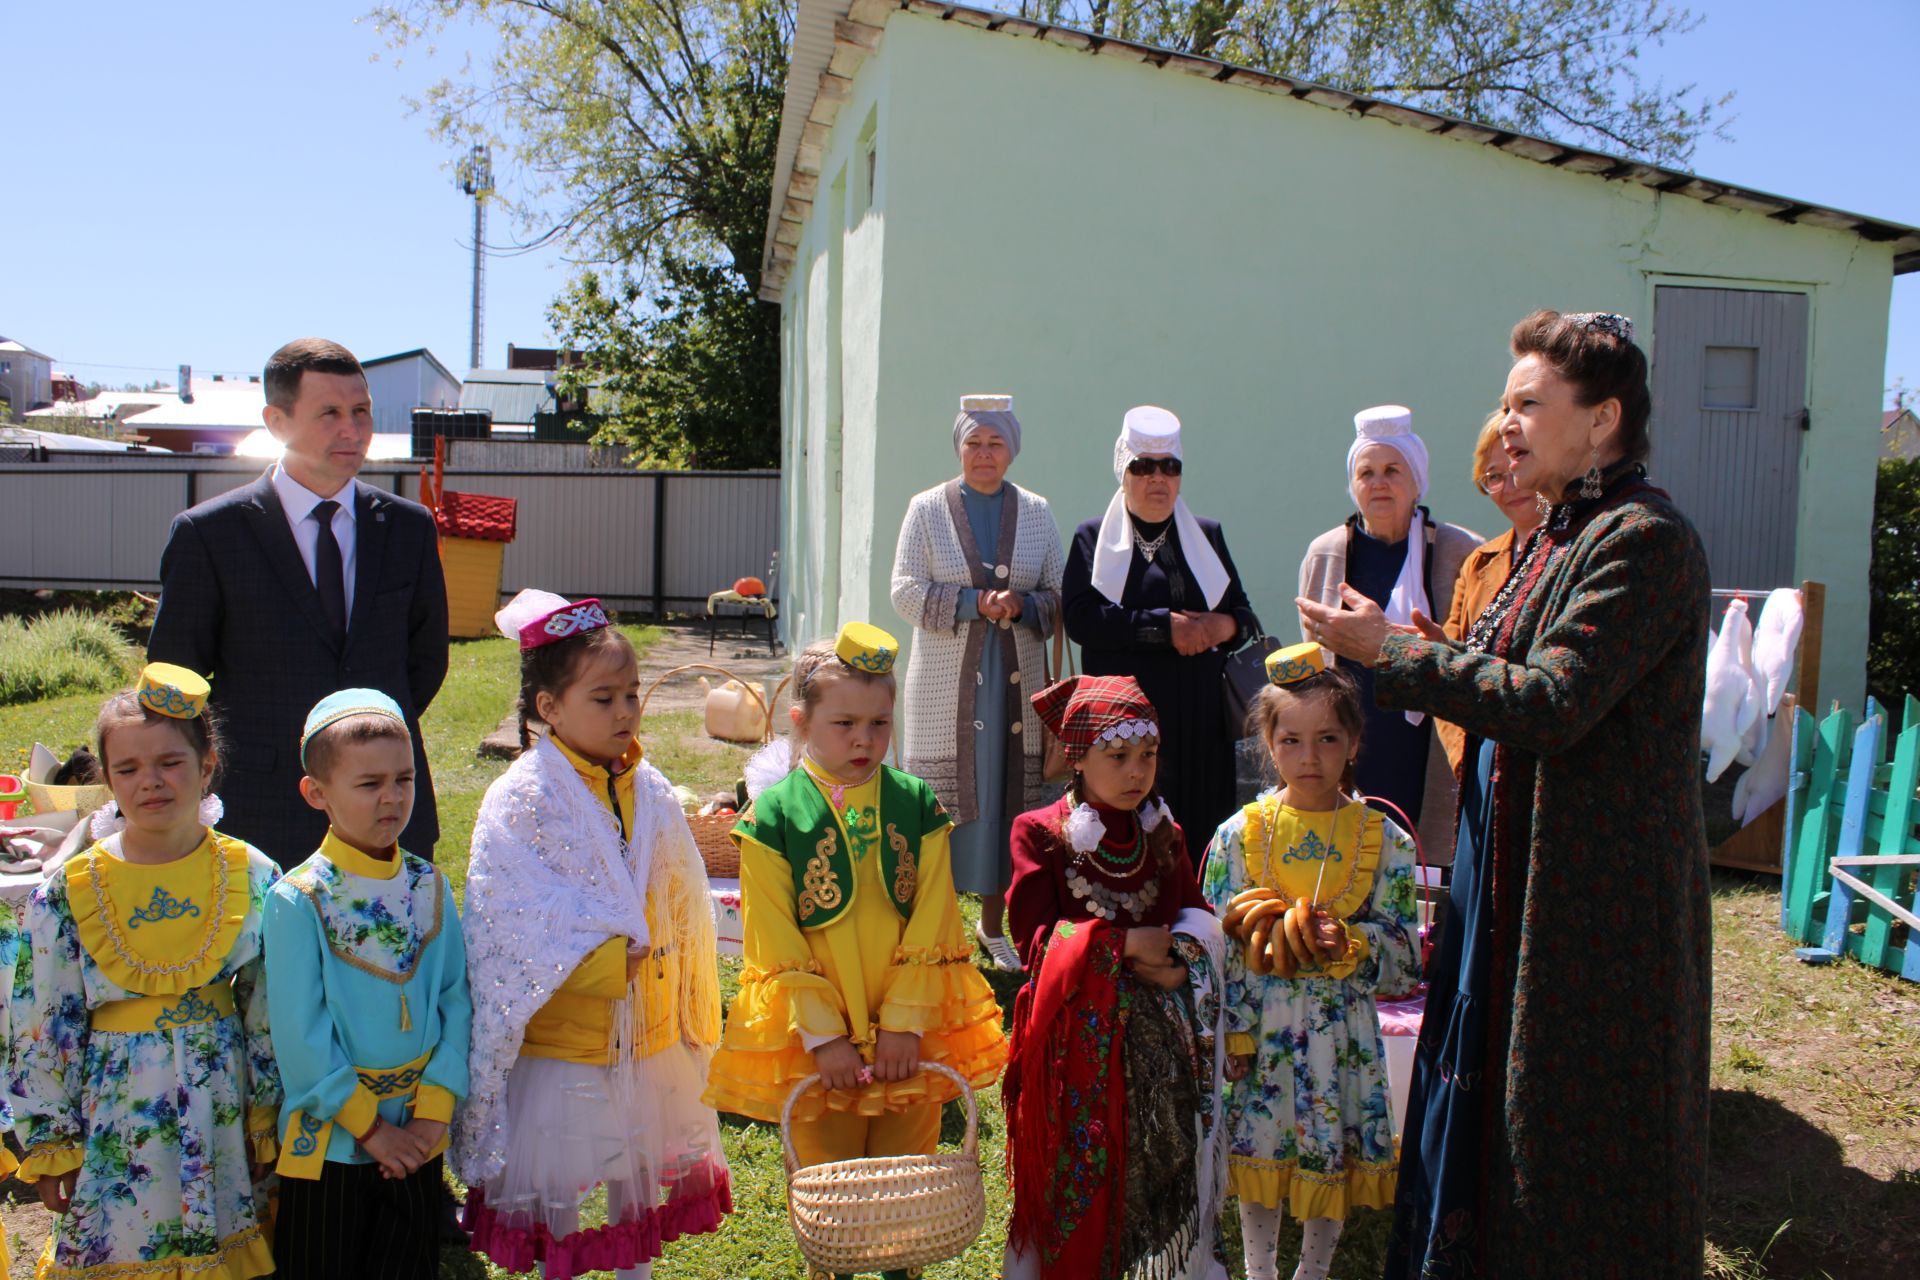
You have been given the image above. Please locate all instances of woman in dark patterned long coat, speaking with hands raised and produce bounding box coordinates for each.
[1300,311,1713,1280]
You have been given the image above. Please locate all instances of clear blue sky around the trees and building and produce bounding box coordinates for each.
[15,0,1920,404]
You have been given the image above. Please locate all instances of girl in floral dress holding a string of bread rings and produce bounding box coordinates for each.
[1202,645,1419,1280]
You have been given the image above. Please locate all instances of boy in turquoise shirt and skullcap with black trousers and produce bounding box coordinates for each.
[265,689,472,1280]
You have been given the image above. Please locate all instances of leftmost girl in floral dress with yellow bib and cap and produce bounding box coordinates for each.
[10,664,280,1280]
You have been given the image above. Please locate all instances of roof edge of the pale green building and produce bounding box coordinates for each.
[760,0,1920,301]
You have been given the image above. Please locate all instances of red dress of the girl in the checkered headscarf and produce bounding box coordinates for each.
[1002,798,1219,1280]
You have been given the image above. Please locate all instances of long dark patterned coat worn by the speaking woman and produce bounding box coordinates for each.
[1375,487,1713,1280]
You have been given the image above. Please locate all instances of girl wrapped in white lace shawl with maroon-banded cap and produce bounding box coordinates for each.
[451,591,732,1280]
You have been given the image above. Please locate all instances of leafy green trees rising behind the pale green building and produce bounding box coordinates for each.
[374,0,1728,466]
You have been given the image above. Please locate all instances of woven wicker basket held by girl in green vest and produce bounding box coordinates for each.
[780,1061,987,1276]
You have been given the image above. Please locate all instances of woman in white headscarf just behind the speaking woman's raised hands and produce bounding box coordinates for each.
[1300,405,1480,865]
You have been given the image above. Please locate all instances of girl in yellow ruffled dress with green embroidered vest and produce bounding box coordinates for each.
[707,622,1006,1274]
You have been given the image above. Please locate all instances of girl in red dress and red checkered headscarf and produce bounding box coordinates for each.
[1002,676,1227,1280]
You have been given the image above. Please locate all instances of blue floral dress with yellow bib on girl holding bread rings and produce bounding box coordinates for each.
[1200,791,1419,1221]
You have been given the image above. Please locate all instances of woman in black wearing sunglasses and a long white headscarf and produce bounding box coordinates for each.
[1060,405,1260,852]
